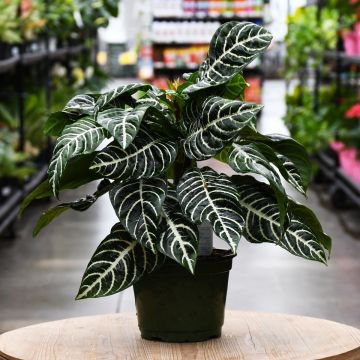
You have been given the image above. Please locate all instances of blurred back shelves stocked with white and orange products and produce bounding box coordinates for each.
[148,0,264,102]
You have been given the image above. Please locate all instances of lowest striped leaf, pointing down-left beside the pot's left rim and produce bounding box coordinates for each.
[76,223,158,300]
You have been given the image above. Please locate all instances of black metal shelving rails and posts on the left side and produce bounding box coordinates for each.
[0,44,89,236]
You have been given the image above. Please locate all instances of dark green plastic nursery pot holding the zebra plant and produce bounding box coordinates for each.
[134,250,234,342]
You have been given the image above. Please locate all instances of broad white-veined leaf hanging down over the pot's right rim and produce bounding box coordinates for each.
[177,167,244,253]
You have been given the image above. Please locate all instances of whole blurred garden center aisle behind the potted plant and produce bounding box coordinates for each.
[0,0,360,333]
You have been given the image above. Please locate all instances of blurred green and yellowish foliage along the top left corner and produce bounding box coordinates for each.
[0,0,119,44]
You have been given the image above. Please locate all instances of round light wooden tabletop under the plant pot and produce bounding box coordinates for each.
[0,311,360,360]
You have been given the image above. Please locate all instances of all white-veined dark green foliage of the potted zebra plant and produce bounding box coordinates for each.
[22,22,331,299]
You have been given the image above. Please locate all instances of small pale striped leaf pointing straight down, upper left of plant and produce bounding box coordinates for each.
[97,106,148,149]
